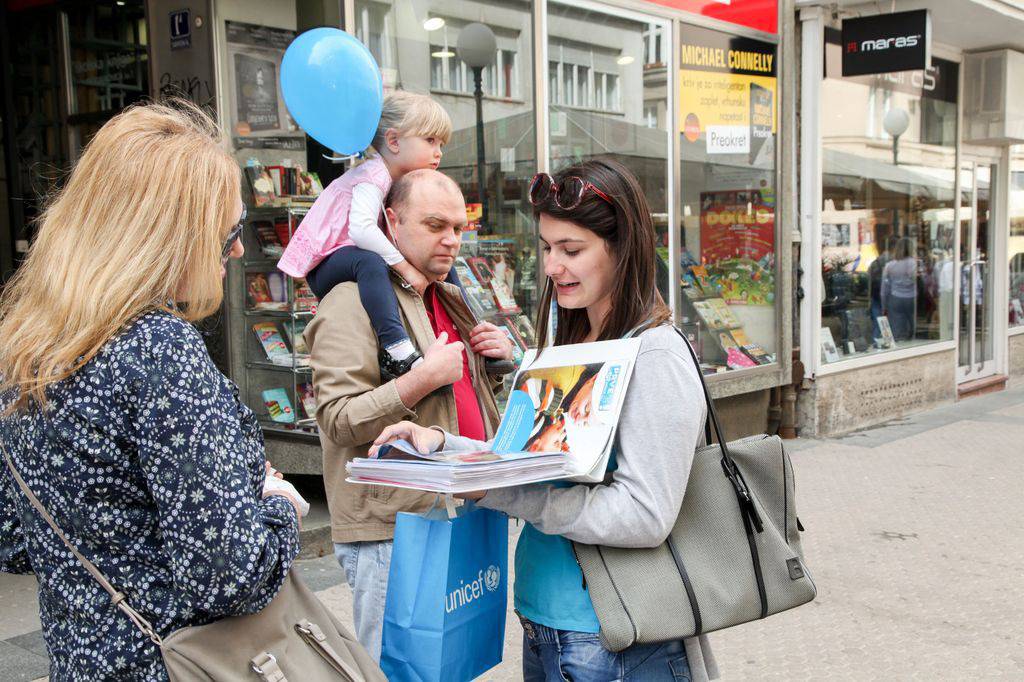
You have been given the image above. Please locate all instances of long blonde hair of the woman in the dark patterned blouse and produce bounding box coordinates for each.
[0,101,242,413]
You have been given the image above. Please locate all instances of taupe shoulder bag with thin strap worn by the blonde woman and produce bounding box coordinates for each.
[0,445,386,682]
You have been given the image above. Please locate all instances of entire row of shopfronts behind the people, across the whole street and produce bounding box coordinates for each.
[0,0,1024,458]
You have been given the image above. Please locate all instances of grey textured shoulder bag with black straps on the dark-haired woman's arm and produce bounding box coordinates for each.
[573,329,816,651]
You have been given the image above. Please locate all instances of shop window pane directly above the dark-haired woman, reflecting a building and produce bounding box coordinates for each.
[546,2,671,300]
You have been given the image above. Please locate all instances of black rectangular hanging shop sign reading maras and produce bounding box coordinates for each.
[843,9,932,76]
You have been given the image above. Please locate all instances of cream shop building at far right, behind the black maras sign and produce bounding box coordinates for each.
[797,0,1024,434]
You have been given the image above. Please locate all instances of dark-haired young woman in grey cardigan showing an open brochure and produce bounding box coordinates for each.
[375,160,718,681]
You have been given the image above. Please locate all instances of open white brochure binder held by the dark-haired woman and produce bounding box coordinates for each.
[347,339,640,493]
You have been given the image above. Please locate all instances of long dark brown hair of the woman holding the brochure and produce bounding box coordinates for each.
[534,158,672,347]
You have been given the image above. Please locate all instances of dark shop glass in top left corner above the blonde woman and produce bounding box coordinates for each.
[3,0,151,240]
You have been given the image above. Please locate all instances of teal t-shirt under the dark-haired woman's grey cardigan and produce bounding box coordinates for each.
[514,450,616,633]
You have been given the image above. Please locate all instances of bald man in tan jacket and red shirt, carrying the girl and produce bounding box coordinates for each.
[305,169,512,660]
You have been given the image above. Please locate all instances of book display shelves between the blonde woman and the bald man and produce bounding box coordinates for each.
[239,206,317,436]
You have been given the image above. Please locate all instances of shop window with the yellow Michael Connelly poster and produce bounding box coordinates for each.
[679,26,779,374]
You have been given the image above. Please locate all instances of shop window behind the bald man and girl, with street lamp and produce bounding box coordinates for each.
[354,0,537,360]
